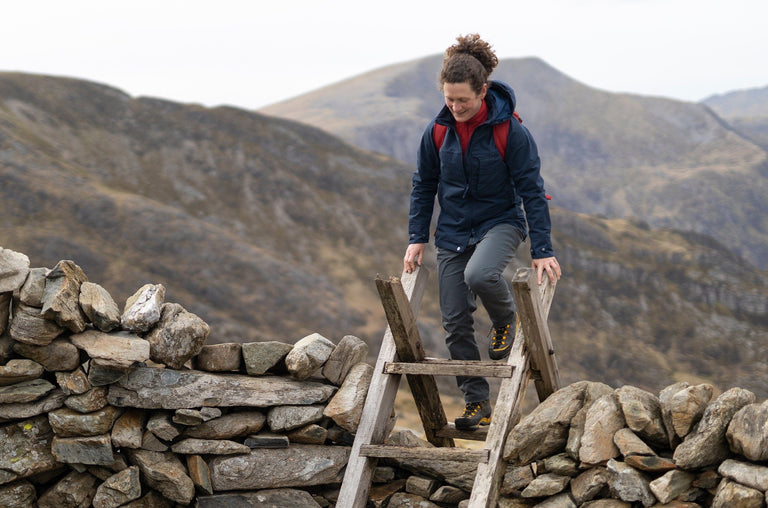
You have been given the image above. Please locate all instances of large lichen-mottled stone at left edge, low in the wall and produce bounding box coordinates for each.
[0,416,60,483]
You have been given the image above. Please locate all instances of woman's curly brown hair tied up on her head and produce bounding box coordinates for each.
[440,34,499,94]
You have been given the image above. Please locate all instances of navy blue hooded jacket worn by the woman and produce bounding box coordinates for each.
[408,81,554,258]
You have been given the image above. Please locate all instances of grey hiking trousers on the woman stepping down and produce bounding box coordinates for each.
[437,224,523,403]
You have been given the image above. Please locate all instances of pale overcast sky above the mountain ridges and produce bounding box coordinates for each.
[0,0,768,109]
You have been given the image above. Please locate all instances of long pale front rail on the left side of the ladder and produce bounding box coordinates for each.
[336,267,429,508]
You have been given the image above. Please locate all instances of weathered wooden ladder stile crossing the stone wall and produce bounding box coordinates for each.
[336,267,560,508]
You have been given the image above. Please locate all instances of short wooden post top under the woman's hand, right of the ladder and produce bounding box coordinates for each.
[512,268,560,401]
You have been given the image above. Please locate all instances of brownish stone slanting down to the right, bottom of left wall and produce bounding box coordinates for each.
[130,450,195,505]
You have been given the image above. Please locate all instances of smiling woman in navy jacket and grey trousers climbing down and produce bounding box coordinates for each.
[403,34,561,429]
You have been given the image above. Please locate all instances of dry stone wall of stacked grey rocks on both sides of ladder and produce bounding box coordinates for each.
[0,248,768,508]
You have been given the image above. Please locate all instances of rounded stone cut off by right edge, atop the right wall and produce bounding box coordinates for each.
[725,401,768,462]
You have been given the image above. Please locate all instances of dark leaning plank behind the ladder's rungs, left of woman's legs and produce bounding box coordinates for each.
[376,277,454,446]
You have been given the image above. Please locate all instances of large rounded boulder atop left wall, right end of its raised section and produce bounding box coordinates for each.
[146,303,211,369]
